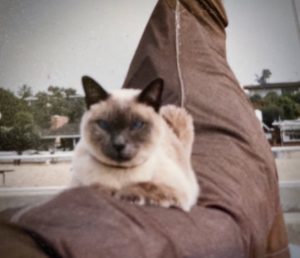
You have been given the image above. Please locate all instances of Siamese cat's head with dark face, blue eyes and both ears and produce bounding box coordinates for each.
[81,76,163,167]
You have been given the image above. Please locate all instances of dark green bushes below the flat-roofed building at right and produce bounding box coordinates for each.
[250,92,300,126]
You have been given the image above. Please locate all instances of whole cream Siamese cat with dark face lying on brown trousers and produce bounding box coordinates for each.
[70,76,199,211]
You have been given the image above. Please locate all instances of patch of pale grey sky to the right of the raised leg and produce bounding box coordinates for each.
[225,0,300,85]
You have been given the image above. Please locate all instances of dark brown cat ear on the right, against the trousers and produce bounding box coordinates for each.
[137,78,164,111]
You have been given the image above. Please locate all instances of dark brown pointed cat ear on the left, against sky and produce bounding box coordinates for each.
[81,76,109,109]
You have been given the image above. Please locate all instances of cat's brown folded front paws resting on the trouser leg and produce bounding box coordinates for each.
[114,182,180,208]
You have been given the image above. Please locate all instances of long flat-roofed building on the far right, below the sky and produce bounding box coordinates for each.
[244,82,300,98]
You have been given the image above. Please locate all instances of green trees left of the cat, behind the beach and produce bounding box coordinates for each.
[0,85,84,152]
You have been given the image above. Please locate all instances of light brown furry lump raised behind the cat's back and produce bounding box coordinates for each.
[160,105,194,156]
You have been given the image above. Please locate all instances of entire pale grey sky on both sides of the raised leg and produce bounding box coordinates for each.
[0,0,300,93]
